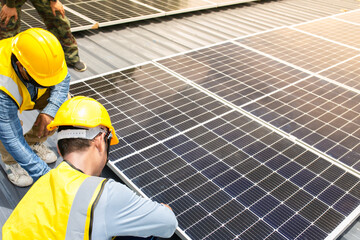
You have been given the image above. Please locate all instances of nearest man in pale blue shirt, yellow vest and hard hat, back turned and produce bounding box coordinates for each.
[2,96,177,240]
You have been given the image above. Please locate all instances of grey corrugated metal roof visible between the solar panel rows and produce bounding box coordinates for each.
[0,0,360,240]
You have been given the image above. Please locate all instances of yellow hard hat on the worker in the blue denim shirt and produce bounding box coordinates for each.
[11,28,68,87]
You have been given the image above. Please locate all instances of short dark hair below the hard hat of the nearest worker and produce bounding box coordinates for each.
[58,126,92,157]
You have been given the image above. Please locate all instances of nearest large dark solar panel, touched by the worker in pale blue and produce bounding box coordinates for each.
[71,63,360,239]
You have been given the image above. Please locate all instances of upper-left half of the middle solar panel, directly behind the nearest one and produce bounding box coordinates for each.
[158,43,309,106]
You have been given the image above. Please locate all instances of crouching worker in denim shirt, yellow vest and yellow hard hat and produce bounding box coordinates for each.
[0,28,70,187]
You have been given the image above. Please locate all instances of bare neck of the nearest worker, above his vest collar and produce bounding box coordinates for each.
[64,147,104,176]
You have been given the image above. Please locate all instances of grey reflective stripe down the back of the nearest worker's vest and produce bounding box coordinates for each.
[65,177,104,240]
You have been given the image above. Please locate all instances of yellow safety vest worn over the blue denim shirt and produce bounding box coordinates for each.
[0,38,47,112]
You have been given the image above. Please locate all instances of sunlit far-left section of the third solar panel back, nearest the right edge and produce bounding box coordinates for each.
[238,28,360,73]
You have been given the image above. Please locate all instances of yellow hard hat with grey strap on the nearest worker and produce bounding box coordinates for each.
[47,96,119,145]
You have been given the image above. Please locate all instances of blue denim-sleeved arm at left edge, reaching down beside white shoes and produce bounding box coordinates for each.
[0,91,50,181]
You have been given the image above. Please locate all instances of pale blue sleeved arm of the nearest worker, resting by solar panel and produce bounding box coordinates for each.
[92,180,178,239]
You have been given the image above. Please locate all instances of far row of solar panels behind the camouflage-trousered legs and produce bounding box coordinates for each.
[22,0,254,32]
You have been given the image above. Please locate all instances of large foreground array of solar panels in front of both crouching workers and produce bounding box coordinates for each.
[71,11,360,240]
